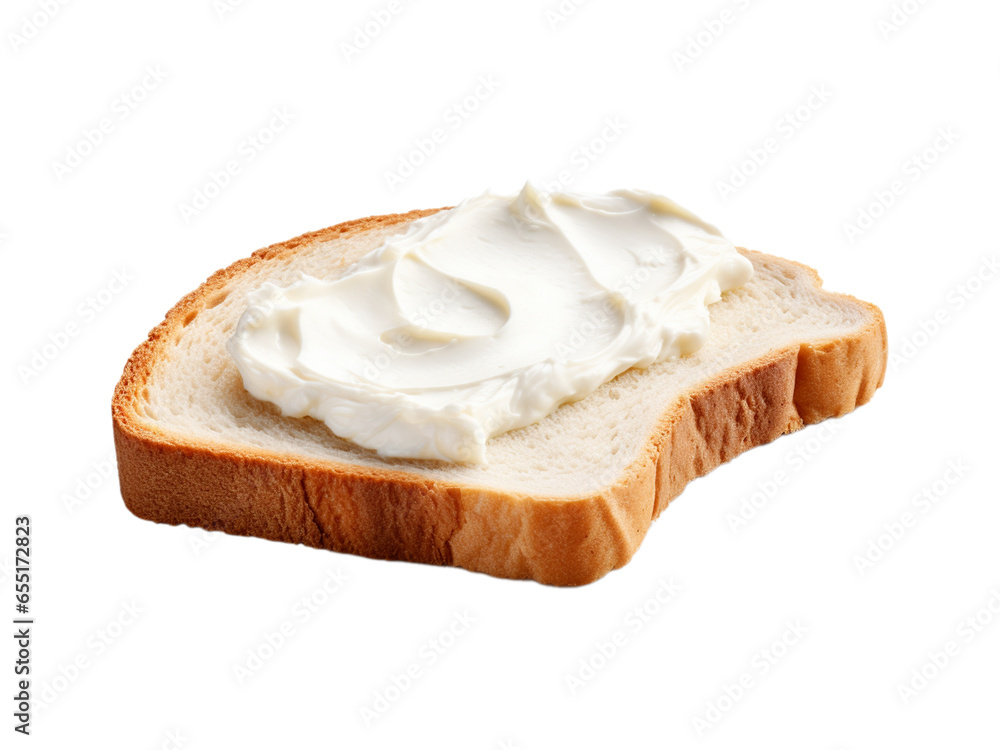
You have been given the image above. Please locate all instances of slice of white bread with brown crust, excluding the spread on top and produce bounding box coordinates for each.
[112,209,886,585]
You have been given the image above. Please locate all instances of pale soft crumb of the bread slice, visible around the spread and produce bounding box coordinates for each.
[134,217,870,498]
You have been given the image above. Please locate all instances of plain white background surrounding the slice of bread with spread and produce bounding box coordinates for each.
[0,0,1000,750]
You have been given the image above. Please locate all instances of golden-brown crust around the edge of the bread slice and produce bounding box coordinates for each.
[112,209,887,586]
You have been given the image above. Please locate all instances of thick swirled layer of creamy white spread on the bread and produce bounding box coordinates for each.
[228,183,753,463]
